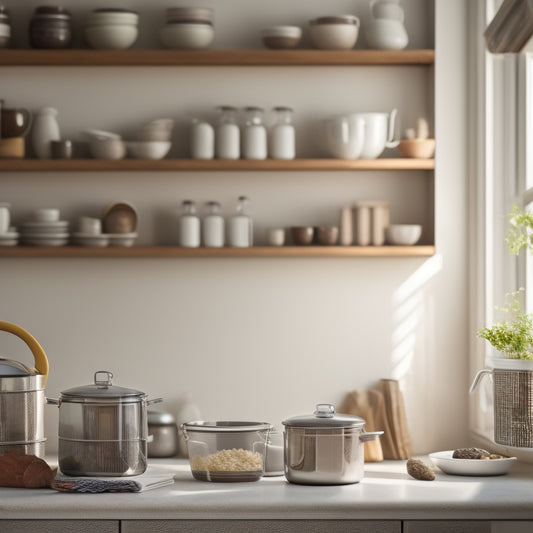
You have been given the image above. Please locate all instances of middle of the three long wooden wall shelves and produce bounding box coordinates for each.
[0,158,435,172]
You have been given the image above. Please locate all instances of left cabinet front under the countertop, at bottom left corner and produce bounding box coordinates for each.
[0,520,120,533]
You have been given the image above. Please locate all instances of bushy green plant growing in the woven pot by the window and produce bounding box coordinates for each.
[477,289,533,360]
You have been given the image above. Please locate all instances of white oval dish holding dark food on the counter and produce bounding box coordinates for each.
[429,450,516,476]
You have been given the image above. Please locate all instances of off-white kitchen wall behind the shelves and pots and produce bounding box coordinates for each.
[0,0,469,453]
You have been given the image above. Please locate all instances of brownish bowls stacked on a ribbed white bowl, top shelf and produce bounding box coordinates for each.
[160,7,215,50]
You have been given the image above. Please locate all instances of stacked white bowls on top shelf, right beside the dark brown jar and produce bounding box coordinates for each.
[85,8,139,50]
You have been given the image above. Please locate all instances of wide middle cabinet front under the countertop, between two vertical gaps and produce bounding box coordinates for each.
[121,520,402,533]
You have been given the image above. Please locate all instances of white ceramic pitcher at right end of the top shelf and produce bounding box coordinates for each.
[366,0,409,50]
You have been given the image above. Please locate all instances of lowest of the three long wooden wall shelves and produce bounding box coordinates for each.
[0,245,435,258]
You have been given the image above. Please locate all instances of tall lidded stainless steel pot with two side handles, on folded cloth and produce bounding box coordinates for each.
[47,371,161,476]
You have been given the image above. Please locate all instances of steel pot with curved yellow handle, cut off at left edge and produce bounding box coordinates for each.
[0,321,48,457]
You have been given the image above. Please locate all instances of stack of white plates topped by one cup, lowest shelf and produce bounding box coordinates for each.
[20,208,69,246]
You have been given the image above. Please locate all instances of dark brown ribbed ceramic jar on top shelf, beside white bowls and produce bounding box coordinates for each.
[29,6,72,49]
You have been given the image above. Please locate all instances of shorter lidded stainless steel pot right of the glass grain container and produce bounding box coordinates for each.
[283,404,383,485]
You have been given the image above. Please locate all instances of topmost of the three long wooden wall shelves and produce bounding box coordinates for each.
[0,49,435,67]
